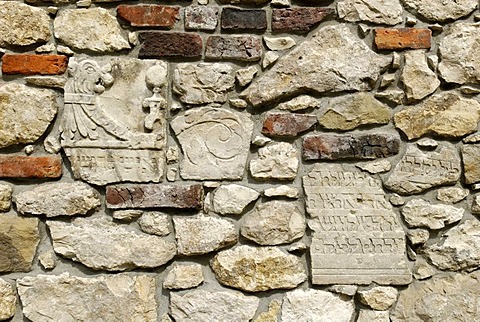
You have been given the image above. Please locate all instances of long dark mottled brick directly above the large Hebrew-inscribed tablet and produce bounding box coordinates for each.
[303,134,400,160]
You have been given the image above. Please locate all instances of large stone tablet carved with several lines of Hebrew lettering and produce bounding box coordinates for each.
[303,164,412,285]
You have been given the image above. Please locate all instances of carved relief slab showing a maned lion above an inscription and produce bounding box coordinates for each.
[61,59,167,185]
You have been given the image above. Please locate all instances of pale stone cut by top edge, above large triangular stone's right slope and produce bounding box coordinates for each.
[337,0,403,25]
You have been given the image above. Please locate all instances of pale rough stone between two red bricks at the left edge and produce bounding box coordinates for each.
[0,83,58,148]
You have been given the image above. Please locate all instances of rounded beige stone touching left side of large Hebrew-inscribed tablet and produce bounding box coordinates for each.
[241,201,306,245]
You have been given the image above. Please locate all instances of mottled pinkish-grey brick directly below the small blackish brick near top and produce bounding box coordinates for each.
[205,36,262,61]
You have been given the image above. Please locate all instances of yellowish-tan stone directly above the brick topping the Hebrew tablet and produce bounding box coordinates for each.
[318,92,391,131]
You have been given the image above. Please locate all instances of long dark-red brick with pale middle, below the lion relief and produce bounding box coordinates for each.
[106,184,203,209]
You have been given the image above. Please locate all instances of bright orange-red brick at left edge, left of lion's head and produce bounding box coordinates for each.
[2,54,68,75]
